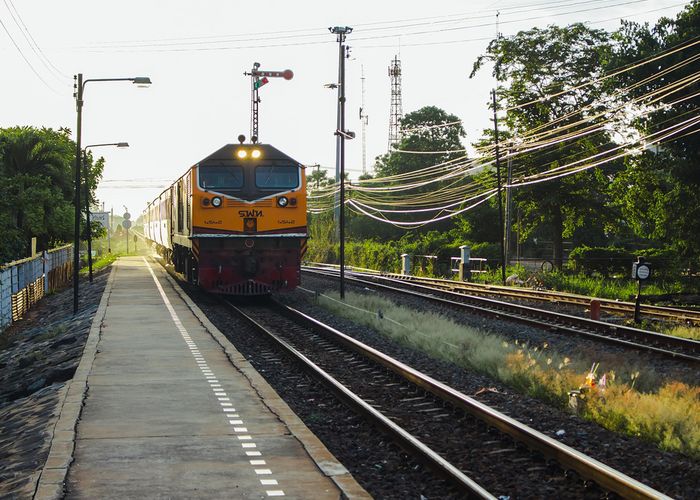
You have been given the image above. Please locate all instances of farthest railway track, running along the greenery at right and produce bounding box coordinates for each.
[303,264,700,326]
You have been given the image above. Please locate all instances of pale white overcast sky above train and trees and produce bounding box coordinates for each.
[0,0,685,215]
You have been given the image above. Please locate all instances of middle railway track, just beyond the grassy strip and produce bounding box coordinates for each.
[304,268,700,363]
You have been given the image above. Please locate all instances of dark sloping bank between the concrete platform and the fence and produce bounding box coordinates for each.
[0,268,111,498]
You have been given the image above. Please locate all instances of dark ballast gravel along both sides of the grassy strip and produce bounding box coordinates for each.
[279,275,700,499]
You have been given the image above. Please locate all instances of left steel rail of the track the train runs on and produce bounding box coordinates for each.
[224,300,496,500]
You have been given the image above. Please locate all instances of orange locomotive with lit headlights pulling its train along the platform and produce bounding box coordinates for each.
[144,136,307,295]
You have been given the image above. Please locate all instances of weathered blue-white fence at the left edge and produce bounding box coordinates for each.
[0,245,73,330]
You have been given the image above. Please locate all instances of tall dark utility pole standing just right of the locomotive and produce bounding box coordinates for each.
[328,26,355,300]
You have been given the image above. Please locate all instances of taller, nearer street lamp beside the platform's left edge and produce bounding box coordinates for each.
[73,73,151,314]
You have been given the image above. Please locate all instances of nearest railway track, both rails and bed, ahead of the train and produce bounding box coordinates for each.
[227,302,667,498]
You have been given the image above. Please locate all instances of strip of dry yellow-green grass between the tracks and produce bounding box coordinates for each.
[319,293,700,458]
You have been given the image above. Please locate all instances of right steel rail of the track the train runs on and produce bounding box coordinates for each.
[270,304,669,499]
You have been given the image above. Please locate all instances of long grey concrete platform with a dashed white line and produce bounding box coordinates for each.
[54,257,368,499]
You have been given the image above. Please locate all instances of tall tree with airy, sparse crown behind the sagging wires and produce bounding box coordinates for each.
[471,24,611,267]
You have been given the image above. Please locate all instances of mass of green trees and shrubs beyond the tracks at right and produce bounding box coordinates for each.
[312,5,700,282]
